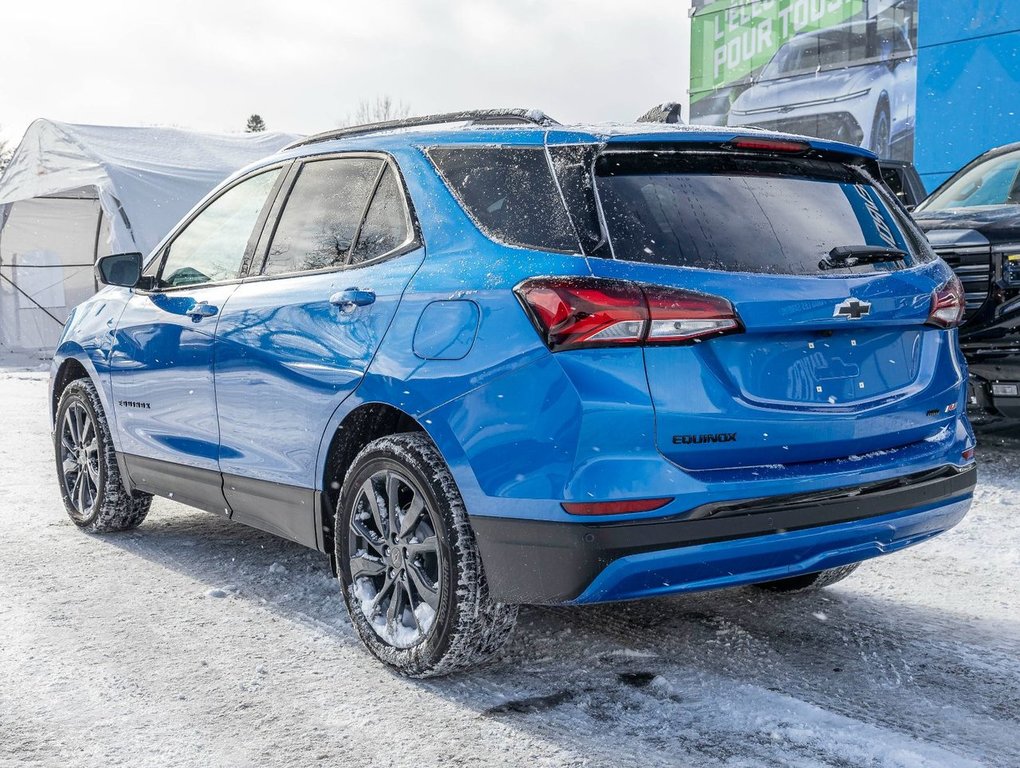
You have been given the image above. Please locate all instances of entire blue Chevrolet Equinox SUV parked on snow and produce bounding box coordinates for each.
[52,110,976,676]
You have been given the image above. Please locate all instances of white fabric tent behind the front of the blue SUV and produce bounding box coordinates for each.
[0,119,298,349]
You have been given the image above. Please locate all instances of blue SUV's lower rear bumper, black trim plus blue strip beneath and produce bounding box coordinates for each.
[472,465,977,603]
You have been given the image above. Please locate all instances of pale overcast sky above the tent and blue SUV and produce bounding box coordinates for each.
[0,0,690,144]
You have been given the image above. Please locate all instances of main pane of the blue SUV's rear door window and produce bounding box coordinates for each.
[263,157,383,274]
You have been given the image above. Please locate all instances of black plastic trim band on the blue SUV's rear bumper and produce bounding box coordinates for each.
[471,465,977,603]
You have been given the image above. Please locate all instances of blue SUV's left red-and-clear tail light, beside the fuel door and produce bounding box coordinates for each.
[514,277,743,352]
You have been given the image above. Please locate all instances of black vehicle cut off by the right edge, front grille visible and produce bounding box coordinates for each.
[914,143,1020,420]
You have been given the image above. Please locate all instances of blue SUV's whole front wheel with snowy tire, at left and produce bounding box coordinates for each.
[53,378,152,533]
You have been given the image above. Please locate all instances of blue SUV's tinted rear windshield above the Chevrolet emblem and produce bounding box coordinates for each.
[596,152,927,274]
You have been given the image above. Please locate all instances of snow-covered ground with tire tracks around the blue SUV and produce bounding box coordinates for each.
[0,368,1020,767]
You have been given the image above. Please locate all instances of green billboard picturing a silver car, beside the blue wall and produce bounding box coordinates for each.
[691,0,917,160]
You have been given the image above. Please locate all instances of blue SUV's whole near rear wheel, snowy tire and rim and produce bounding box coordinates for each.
[334,432,517,677]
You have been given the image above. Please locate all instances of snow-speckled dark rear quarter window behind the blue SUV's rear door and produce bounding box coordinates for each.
[428,146,578,253]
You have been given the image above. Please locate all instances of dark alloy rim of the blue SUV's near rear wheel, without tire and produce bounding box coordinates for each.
[348,469,444,649]
